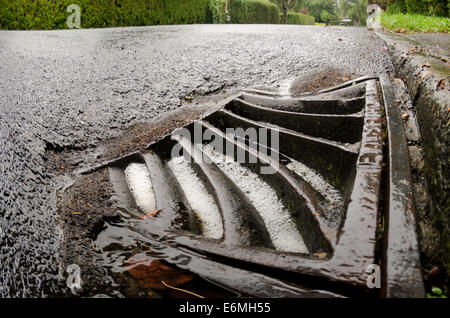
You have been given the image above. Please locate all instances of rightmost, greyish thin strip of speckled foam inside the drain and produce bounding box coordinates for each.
[286,160,344,205]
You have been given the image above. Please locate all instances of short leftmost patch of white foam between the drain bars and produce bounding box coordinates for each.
[125,163,156,213]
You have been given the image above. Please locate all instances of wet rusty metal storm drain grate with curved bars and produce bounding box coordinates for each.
[78,77,421,297]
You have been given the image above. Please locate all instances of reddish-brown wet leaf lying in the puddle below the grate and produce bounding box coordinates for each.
[127,260,194,290]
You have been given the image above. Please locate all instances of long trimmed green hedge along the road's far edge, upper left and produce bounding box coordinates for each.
[0,0,213,30]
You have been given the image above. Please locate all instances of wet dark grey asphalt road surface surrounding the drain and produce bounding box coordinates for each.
[0,25,392,296]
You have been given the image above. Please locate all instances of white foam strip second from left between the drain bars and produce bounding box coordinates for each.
[167,157,223,239]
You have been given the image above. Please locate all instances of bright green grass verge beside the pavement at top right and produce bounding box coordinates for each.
[381,13,450,32]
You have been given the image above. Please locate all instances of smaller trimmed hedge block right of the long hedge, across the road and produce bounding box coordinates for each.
[228,0,280,24]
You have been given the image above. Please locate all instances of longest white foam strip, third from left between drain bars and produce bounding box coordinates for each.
[204,144,308,253]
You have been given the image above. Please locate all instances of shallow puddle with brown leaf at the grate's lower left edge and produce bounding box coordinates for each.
[95,222,242,298]
